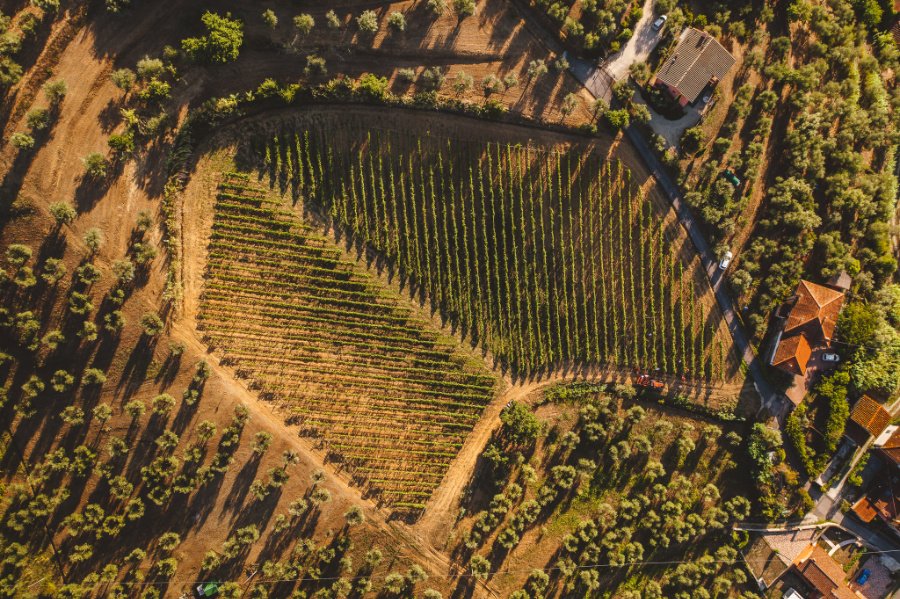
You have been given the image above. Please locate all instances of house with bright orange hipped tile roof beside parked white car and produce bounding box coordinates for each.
[769,280,846,376]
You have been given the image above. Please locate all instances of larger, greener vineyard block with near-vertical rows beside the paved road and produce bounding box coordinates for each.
[250,116,733,381]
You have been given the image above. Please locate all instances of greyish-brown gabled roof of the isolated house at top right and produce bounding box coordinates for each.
[656,27,735,102]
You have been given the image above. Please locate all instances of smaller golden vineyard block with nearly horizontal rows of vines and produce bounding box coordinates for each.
[199,173,496,511]
